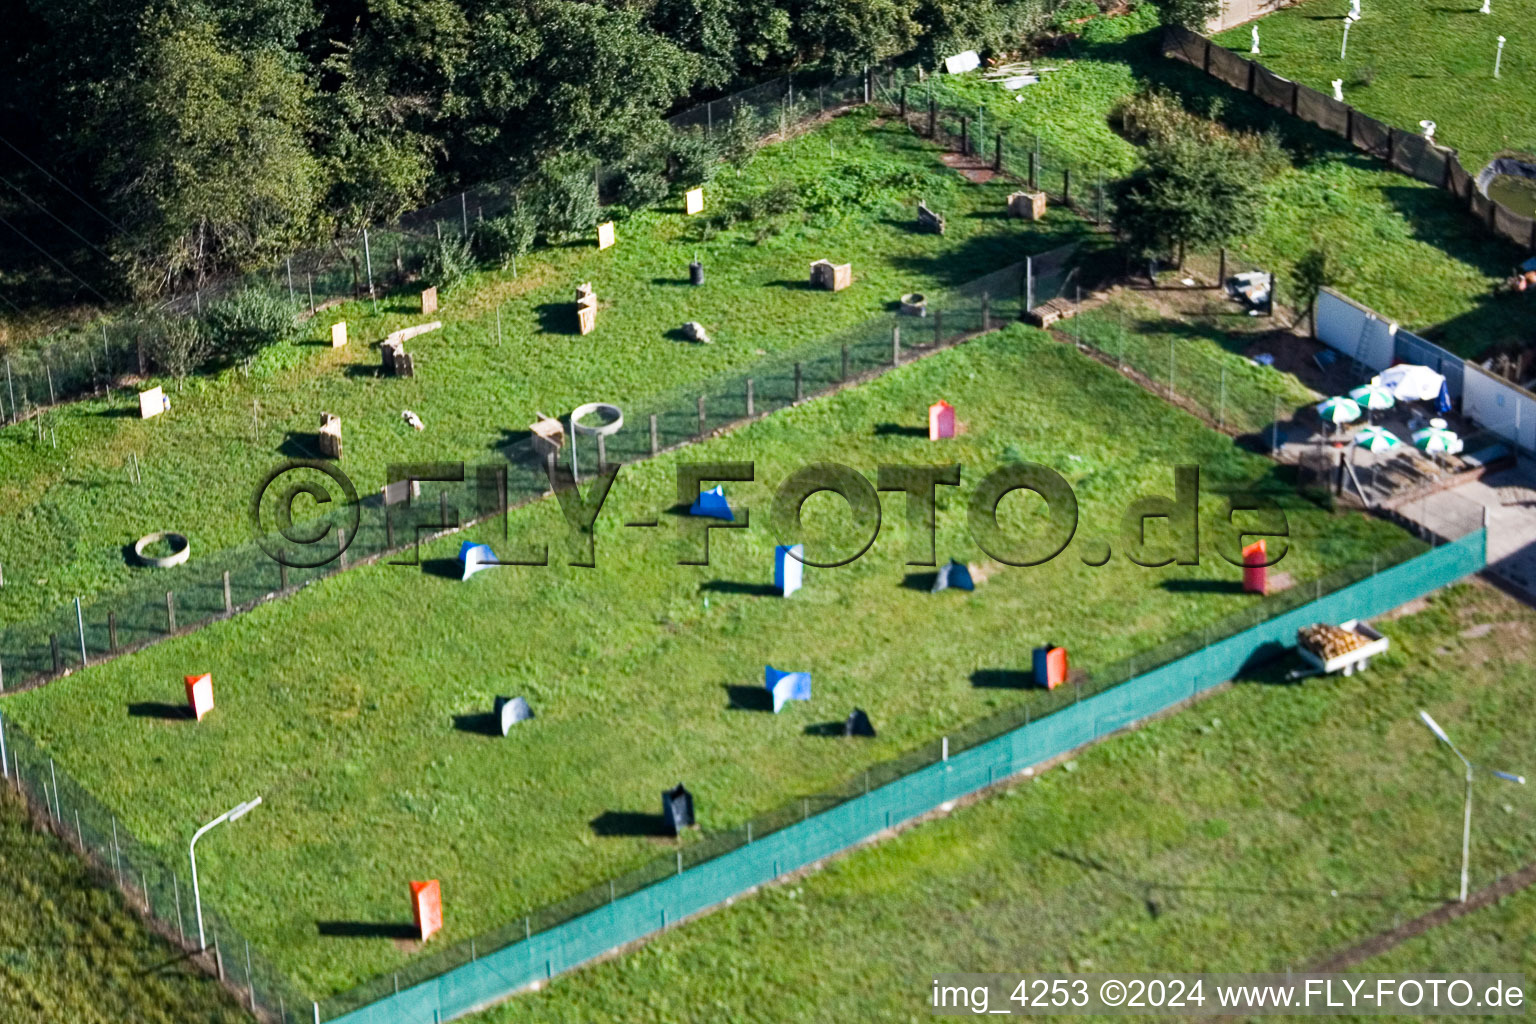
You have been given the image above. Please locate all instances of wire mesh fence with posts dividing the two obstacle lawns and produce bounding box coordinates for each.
[0,256,1044,689]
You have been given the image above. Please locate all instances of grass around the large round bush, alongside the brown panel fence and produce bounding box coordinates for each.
[937,16,1530,355]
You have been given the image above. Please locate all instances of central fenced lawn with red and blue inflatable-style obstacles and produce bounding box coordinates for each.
[5,325,1402,993]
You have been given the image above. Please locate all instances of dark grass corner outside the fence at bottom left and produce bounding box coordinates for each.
[0,789,250,1024]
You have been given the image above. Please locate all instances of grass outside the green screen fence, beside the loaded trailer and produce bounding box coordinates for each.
[473,585,1536,1024]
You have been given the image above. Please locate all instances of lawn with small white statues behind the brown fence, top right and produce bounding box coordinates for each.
[1217,0,1536,175]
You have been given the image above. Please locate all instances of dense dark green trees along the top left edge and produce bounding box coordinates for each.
[0,0,1057,298]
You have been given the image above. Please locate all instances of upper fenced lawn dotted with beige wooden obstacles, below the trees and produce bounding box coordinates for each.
[0,111,1083,626]
